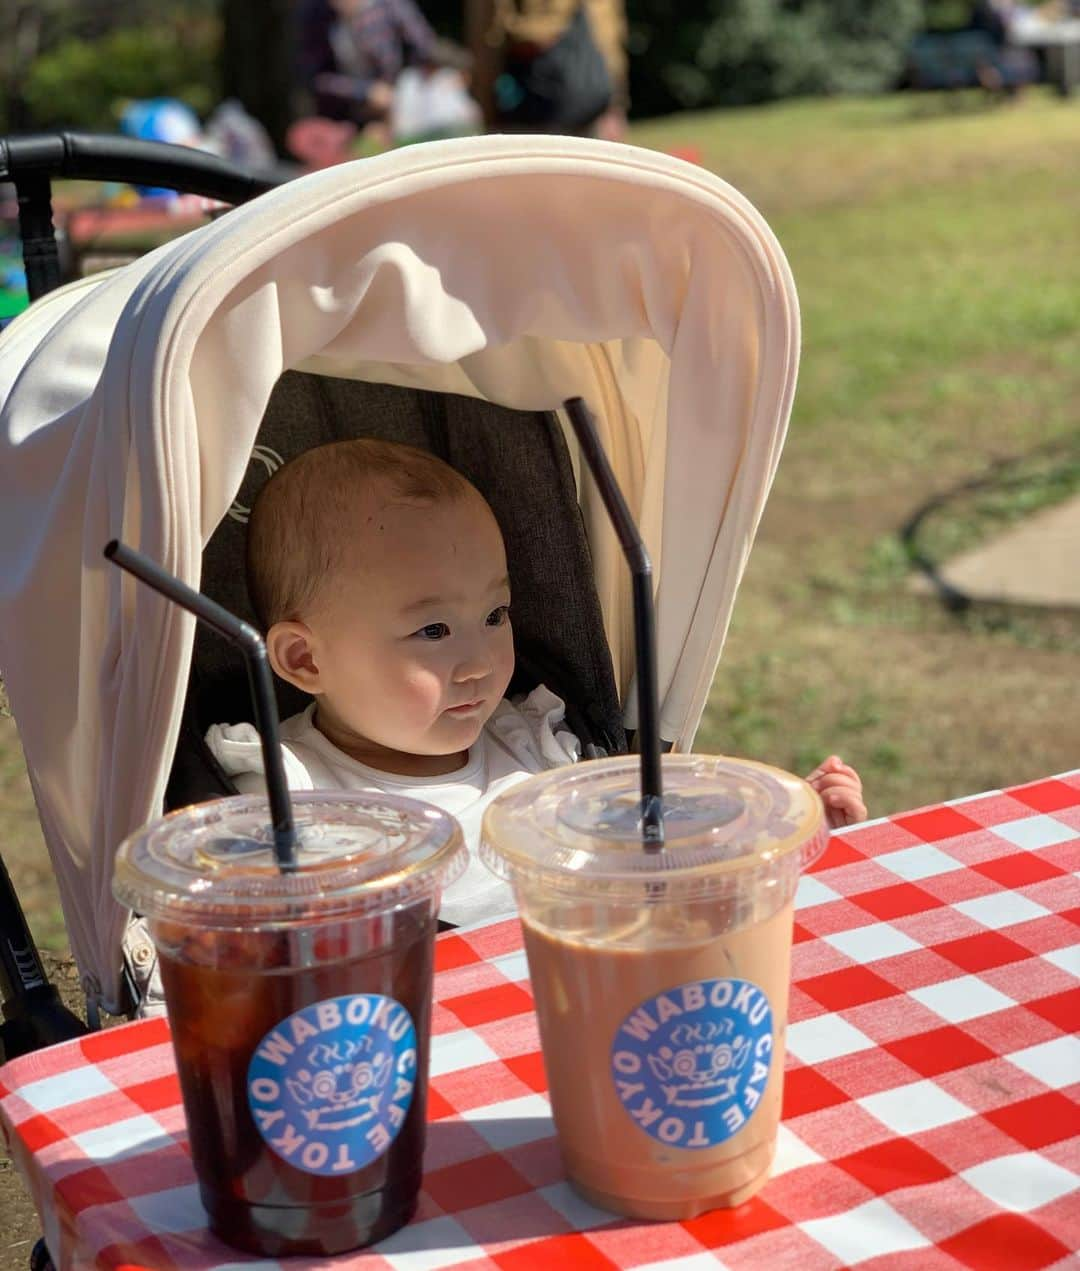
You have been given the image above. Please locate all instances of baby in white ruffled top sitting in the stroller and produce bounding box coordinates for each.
[207,440,865,924]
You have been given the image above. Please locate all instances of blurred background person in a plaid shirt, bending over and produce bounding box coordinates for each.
[299,0,438,126]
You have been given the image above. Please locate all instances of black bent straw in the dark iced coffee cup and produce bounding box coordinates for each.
[105,539,296,873]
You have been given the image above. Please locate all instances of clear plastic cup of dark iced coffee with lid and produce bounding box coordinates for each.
[113,793,466,1257]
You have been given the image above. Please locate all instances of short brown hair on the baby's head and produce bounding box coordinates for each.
[246,437,478,632]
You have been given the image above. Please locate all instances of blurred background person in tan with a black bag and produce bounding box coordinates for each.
[465,0,629,141]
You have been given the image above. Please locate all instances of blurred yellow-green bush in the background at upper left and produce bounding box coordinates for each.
[24,14,221,131]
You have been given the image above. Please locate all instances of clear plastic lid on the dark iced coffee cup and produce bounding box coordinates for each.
[113,792,468,928]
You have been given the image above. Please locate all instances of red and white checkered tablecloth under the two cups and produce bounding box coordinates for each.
[0,773,1080,1271]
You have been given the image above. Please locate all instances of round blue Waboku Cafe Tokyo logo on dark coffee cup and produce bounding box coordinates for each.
[248,993,417,1177]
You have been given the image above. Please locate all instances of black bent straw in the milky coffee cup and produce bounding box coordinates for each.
[563,398,663,852]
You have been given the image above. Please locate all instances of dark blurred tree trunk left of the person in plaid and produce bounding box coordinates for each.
[221,0,295,155]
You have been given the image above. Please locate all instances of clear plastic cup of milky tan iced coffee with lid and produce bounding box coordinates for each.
[482,755,827,1220]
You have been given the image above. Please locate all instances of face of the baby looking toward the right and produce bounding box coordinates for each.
[309,494,513,771]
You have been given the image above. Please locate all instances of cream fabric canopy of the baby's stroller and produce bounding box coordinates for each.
[0,136,799,1009]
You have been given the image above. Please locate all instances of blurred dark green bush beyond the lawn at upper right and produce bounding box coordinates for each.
[628,0,922,116]
